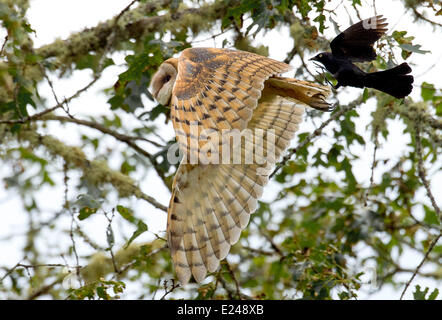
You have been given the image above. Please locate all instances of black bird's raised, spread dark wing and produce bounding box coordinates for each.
[330,15,388,61]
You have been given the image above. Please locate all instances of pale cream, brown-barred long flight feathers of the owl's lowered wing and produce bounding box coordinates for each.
[167,92,304,285]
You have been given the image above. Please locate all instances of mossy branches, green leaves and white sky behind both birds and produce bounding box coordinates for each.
[0,0,442,299]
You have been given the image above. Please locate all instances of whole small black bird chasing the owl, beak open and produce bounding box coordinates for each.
[310,15,414,98]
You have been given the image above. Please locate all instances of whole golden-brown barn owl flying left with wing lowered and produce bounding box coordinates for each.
[150,48,330,285]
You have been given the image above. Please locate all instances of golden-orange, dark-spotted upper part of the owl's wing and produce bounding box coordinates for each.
[171,48,291,156]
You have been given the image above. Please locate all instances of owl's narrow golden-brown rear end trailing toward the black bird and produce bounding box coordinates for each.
[264,76,333,111]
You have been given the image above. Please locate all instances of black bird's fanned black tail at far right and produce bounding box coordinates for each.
[365,62,414,99]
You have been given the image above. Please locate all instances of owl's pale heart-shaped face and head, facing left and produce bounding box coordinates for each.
[150,58,178,106]
